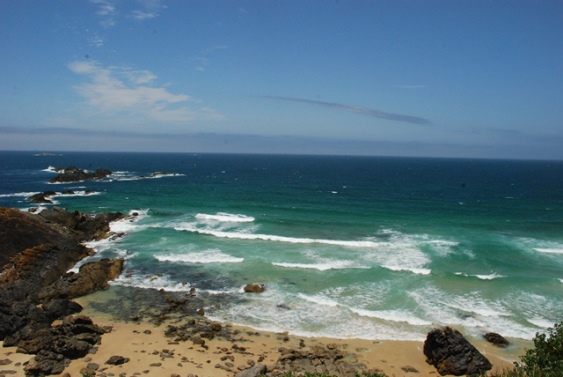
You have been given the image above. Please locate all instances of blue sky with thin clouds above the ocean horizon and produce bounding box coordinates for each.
[0,0,563,159]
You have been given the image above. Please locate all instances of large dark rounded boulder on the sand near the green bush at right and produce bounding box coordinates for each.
[424,327,493,376]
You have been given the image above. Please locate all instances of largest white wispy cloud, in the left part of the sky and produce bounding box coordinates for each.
[68,61,221,122]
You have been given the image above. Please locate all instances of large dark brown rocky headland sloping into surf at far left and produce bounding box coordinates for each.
[0,207,123,376]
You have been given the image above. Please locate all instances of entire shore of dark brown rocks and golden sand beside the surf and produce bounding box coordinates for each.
[0,207,524,377]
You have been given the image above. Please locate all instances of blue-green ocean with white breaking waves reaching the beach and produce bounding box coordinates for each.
[0,152,563,340]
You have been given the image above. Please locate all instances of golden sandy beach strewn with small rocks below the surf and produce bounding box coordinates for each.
[0,288,530,377]
